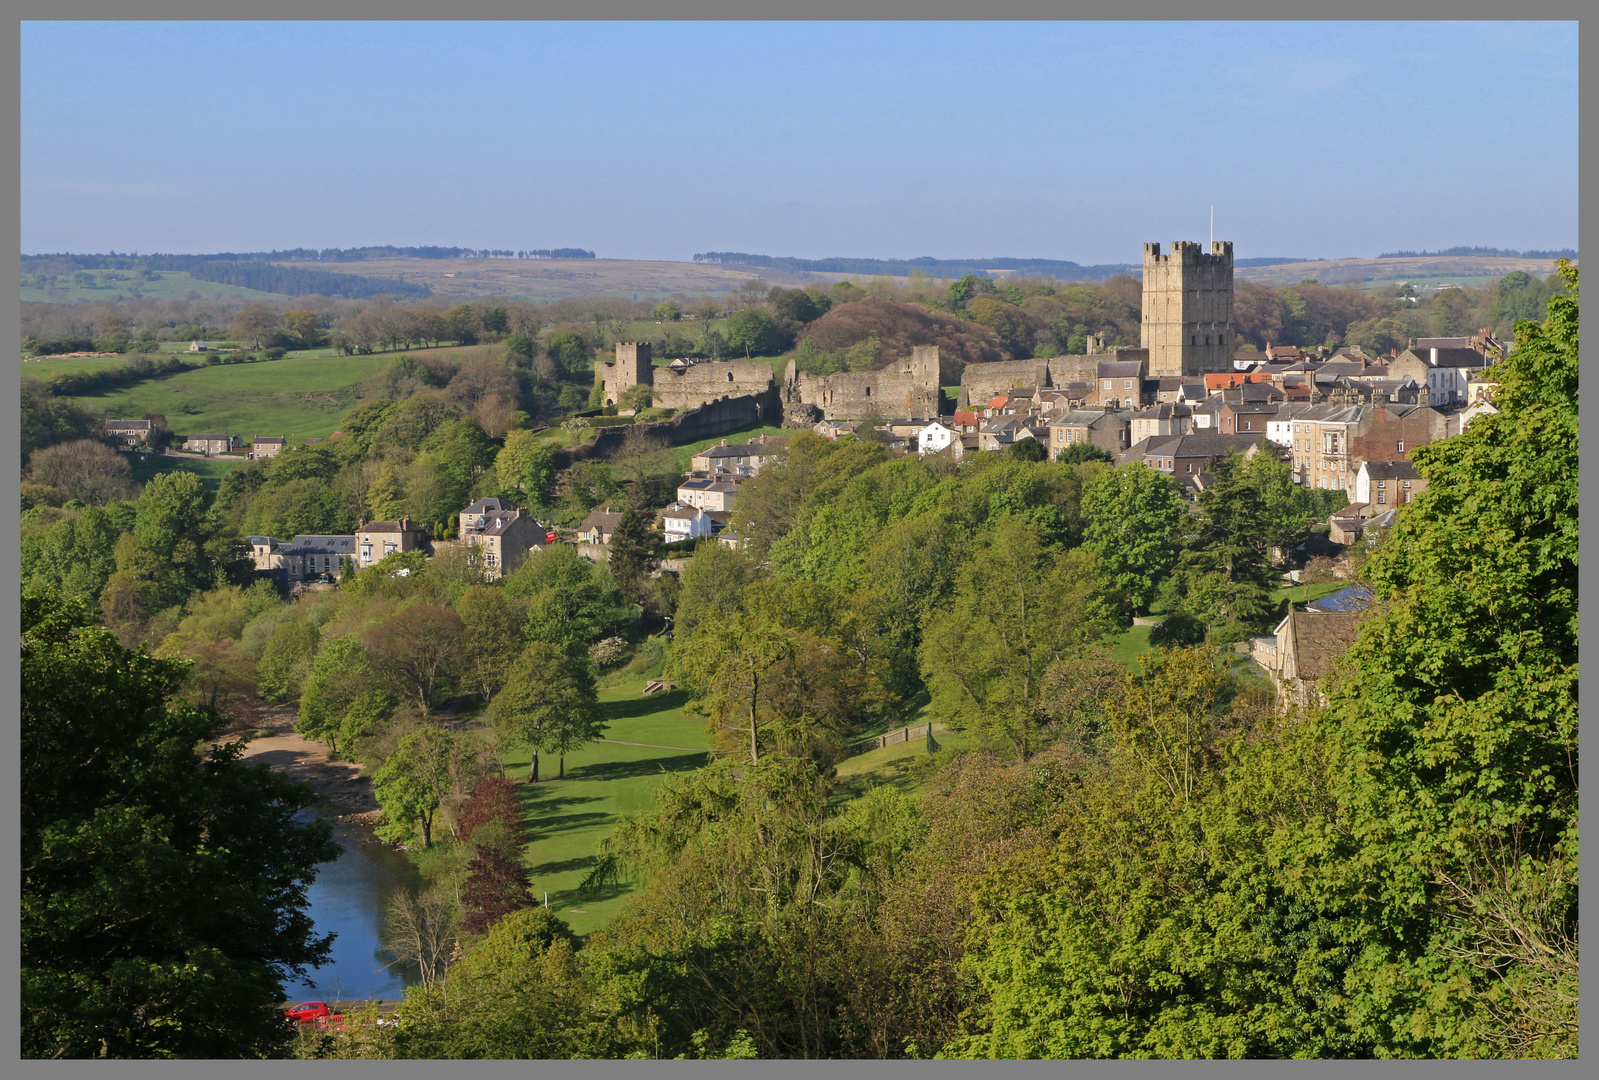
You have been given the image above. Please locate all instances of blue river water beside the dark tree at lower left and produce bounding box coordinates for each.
[283,811,417,1002]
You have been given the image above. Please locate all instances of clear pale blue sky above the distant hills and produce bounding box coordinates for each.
[21,22,1578,264]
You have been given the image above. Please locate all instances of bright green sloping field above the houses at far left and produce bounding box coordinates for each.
[69,355,393,442]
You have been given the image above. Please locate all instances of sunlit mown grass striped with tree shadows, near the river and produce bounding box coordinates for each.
[505,678,710,934]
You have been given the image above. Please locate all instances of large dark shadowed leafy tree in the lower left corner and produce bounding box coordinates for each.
[18,594,339,1058]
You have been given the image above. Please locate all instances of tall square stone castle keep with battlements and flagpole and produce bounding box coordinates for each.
[1140,240,1233,379]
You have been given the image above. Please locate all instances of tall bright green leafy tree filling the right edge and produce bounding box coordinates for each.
[1290,257,1578,1056]
